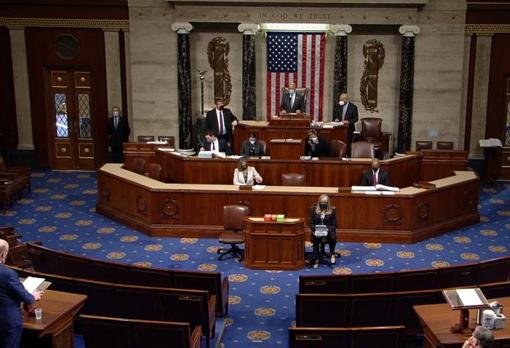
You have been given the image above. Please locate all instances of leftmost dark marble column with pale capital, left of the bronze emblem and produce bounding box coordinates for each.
[172,23,193,149]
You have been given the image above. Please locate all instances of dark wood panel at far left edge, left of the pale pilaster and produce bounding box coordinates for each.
[0,27,18,149]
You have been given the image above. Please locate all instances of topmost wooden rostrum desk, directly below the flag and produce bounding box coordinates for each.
[234,121,348,153]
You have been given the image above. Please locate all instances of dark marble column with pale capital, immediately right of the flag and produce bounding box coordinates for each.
[330,24,352,115]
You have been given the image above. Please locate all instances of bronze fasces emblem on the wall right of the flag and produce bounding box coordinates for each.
[359,39,385,112]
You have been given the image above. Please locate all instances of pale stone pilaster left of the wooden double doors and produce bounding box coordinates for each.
[9,26,34,150]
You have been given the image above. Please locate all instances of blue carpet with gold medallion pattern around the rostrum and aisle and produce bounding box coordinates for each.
[0,171,510,347]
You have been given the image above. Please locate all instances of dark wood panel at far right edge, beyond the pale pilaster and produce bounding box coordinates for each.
[485,34,510,177]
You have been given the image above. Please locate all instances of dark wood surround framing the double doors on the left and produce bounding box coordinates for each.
[26,28,108,167]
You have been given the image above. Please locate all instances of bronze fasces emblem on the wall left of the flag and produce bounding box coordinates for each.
[207,36,232,105]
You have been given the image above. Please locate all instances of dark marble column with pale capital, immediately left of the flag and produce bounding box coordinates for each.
[237,23,259,120]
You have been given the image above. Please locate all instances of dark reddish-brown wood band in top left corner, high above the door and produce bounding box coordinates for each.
[0,0,129,19]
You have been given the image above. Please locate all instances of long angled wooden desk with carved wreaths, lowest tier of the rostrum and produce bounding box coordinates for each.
[96,164,480,243]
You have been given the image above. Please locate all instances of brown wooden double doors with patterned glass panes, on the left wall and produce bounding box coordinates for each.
[45,70,95,169]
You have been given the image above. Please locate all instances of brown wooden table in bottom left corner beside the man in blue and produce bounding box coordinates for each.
[23,290,87,348]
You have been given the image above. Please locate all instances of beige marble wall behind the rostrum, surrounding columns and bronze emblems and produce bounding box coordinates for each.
[129,0,466,152]
